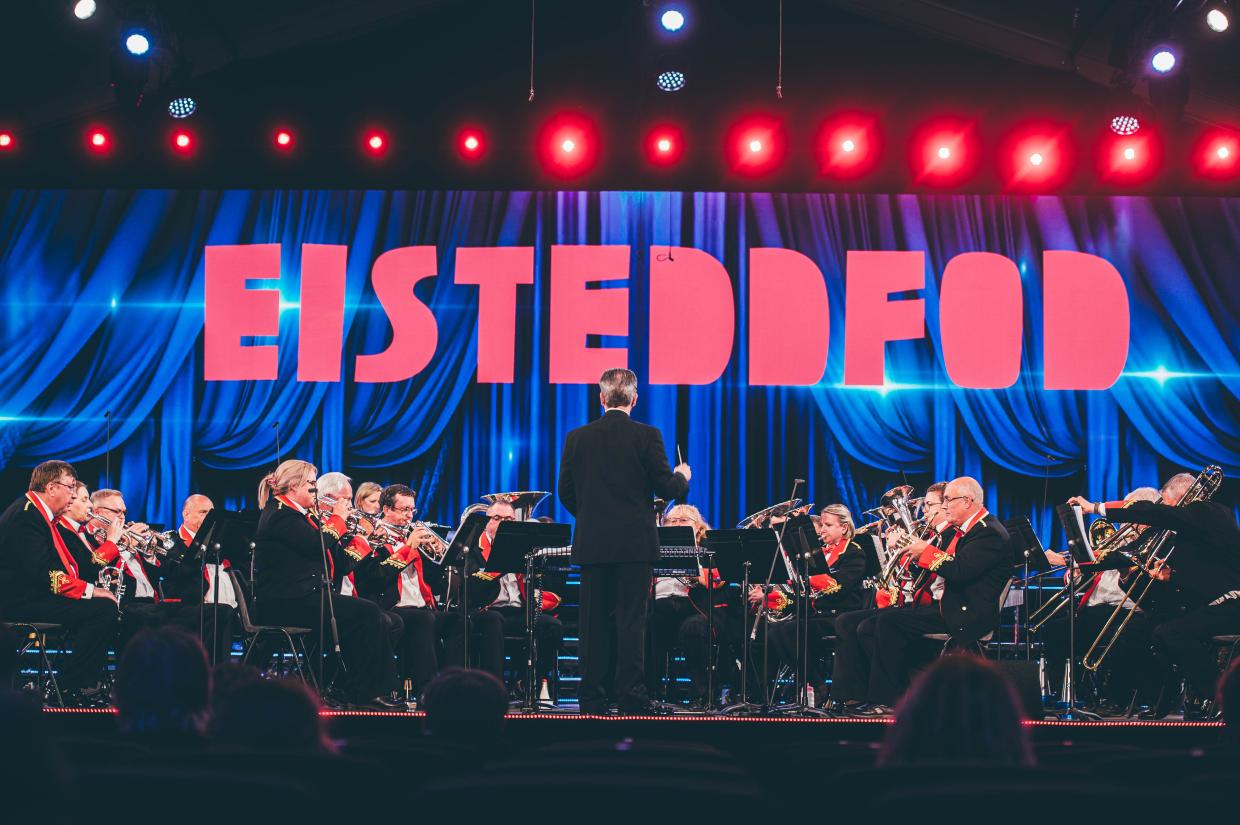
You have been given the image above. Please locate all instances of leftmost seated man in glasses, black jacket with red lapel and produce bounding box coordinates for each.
[0,460,119,706]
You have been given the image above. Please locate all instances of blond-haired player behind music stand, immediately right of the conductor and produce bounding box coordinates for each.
[646,504,724,710]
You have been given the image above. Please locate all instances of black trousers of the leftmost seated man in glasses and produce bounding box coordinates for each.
[5,594,120,691]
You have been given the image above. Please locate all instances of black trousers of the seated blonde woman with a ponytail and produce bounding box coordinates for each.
[259,594,381,702]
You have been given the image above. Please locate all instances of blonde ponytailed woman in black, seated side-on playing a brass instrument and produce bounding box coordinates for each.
[254,459,393,710]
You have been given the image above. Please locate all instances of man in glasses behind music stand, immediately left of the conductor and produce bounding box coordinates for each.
[469,501,564,692]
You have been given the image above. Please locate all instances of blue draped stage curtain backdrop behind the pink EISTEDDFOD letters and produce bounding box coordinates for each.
[0,190,1240,540]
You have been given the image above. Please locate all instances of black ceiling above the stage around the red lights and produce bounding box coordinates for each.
[0,0,1240,191]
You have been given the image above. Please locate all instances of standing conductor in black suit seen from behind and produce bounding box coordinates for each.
[559,368,692,713]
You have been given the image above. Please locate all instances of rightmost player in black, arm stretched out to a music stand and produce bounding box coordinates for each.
[1068,473,1240,718]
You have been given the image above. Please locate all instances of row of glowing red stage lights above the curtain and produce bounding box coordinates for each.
[0,114,1240,189]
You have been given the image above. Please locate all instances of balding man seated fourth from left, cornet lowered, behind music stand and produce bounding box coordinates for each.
[157,494,241,661]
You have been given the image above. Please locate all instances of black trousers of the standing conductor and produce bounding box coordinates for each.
[578,562,652,712]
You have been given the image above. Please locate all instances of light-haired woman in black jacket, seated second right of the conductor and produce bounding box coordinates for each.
[749,504,866,696]
